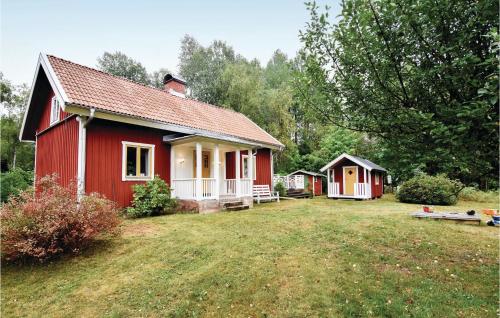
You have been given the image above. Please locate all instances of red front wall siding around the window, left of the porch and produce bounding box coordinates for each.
[85,119,170,207]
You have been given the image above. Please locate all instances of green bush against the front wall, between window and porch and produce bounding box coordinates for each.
[126,176,177,218]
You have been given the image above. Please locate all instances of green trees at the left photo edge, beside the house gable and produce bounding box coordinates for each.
[0,72,34,171]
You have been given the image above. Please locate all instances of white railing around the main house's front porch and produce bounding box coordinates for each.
[172,178,252,200]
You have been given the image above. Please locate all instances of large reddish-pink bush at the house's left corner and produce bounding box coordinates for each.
[0,176,120,261]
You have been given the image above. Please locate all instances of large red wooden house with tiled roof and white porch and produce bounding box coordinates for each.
[20,54,283,209]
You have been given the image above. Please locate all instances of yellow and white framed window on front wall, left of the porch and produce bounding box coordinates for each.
[122,141,155,181]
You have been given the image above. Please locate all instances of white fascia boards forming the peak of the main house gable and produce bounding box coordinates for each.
[19,53,69,141]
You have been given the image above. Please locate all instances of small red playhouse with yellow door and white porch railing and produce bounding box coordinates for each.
[321,153,387,199]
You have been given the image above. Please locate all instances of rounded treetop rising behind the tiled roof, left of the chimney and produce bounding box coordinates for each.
[97,51,150,85]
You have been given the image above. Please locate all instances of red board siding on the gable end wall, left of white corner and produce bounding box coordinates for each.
[35,117,78,186]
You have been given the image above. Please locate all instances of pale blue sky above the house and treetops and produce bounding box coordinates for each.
[0,0,340,84]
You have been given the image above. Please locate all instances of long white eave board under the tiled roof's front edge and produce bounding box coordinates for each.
[66,104,280,150]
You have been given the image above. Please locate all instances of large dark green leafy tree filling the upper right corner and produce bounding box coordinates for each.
[300,0,499,185]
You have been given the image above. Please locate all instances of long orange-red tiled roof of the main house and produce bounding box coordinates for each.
[47,55,283,147]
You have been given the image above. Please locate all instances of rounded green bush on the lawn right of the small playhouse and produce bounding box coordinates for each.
[396,174,463,205]
